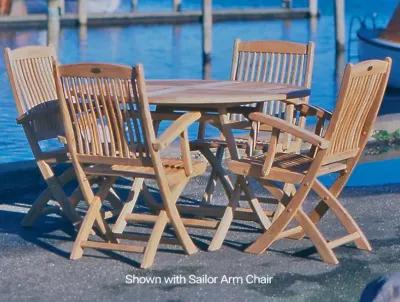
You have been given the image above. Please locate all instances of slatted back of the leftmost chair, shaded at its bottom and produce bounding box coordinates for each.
[4,46,63,140]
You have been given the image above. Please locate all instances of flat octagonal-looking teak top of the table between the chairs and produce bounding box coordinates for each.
[146,80,310,107]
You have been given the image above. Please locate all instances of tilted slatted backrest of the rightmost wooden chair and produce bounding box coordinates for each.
[324,58,392,163]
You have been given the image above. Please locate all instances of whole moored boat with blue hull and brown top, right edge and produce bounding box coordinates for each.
[357,4,400,88]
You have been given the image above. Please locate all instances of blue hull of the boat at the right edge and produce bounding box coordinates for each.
[357,28,400,89]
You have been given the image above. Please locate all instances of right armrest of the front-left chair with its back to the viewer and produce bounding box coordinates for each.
[153,112,201,151]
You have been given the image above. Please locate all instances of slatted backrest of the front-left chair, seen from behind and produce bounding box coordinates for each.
[55,63,155,165]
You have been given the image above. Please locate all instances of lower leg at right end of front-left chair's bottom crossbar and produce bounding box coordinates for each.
[140,210,168,269]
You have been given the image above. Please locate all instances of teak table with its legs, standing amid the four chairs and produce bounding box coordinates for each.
[146,80,310,237]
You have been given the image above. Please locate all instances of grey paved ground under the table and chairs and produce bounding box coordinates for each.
[0,164,400,302]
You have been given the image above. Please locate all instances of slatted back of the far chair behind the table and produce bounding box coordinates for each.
[231,39,314,120]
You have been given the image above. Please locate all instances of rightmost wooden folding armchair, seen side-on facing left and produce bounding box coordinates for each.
[213,58,391,264]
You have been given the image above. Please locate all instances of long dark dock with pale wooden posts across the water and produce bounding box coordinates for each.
[0,0,324,79]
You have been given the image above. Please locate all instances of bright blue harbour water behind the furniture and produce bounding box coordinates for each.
[0,0,400,182]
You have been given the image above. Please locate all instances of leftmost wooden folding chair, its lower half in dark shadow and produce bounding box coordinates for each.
[4,46,121,227]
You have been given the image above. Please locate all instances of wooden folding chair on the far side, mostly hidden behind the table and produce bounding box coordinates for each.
[191,39,314,203]
